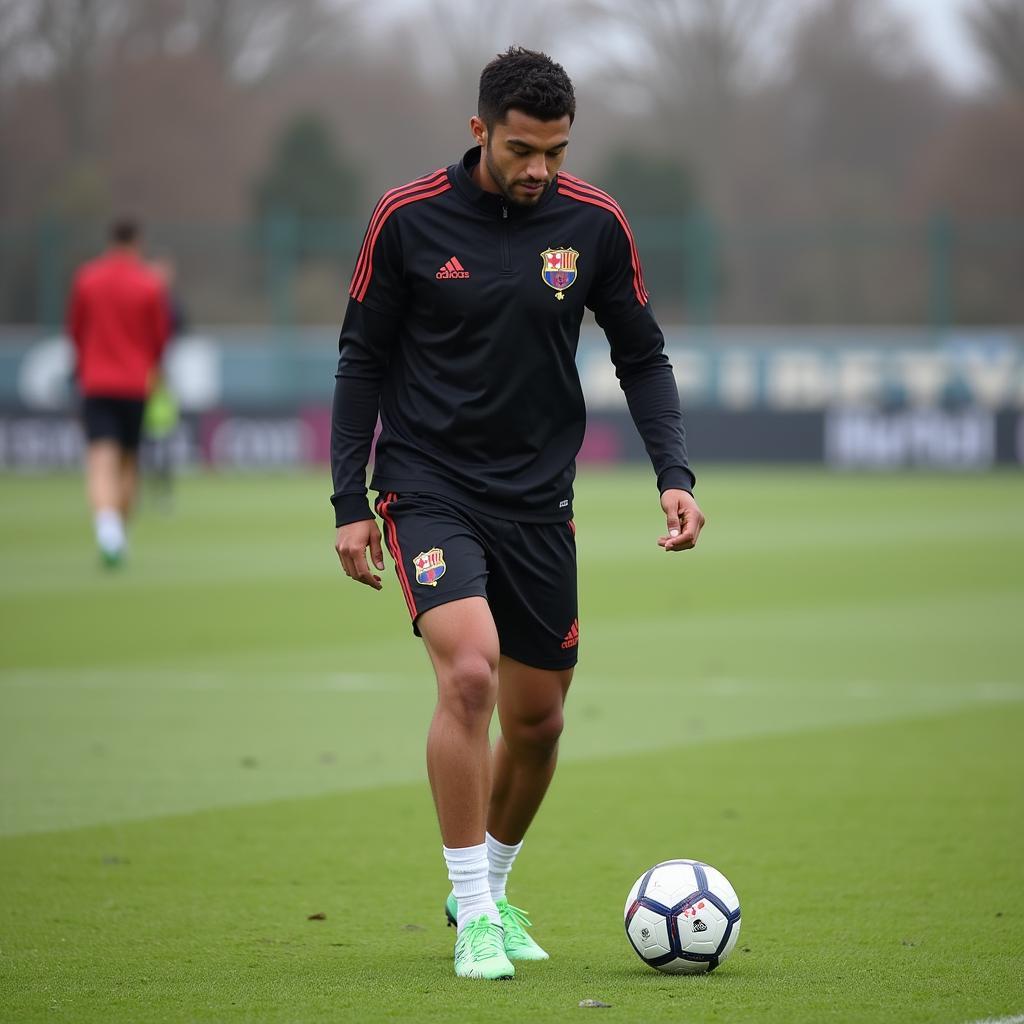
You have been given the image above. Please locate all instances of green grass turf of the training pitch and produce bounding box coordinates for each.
[0,470,1024,1024]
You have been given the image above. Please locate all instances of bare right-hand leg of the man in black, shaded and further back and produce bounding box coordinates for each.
[487,657,572,846]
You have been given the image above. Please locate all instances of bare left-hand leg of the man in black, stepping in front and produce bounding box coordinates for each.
[419,597,499,848]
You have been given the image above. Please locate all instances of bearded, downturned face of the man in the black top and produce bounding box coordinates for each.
[470,110,569,207]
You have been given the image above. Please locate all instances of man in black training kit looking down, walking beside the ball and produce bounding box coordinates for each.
[331,47,703,978]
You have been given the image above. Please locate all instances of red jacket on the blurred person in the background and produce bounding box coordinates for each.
[68,251,170,398]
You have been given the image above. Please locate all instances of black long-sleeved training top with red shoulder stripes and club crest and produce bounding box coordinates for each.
[331,148,694,526]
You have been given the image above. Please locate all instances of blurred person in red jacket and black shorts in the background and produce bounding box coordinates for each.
[68,217,171,567]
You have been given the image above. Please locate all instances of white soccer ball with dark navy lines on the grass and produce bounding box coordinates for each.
[626,860,739,974]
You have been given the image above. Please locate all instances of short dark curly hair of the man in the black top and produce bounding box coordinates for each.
[477,46,575,129]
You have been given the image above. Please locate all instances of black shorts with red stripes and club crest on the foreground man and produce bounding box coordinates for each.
[376,493,580,670]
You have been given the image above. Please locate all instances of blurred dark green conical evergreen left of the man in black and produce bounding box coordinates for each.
[253,113,362,221]
